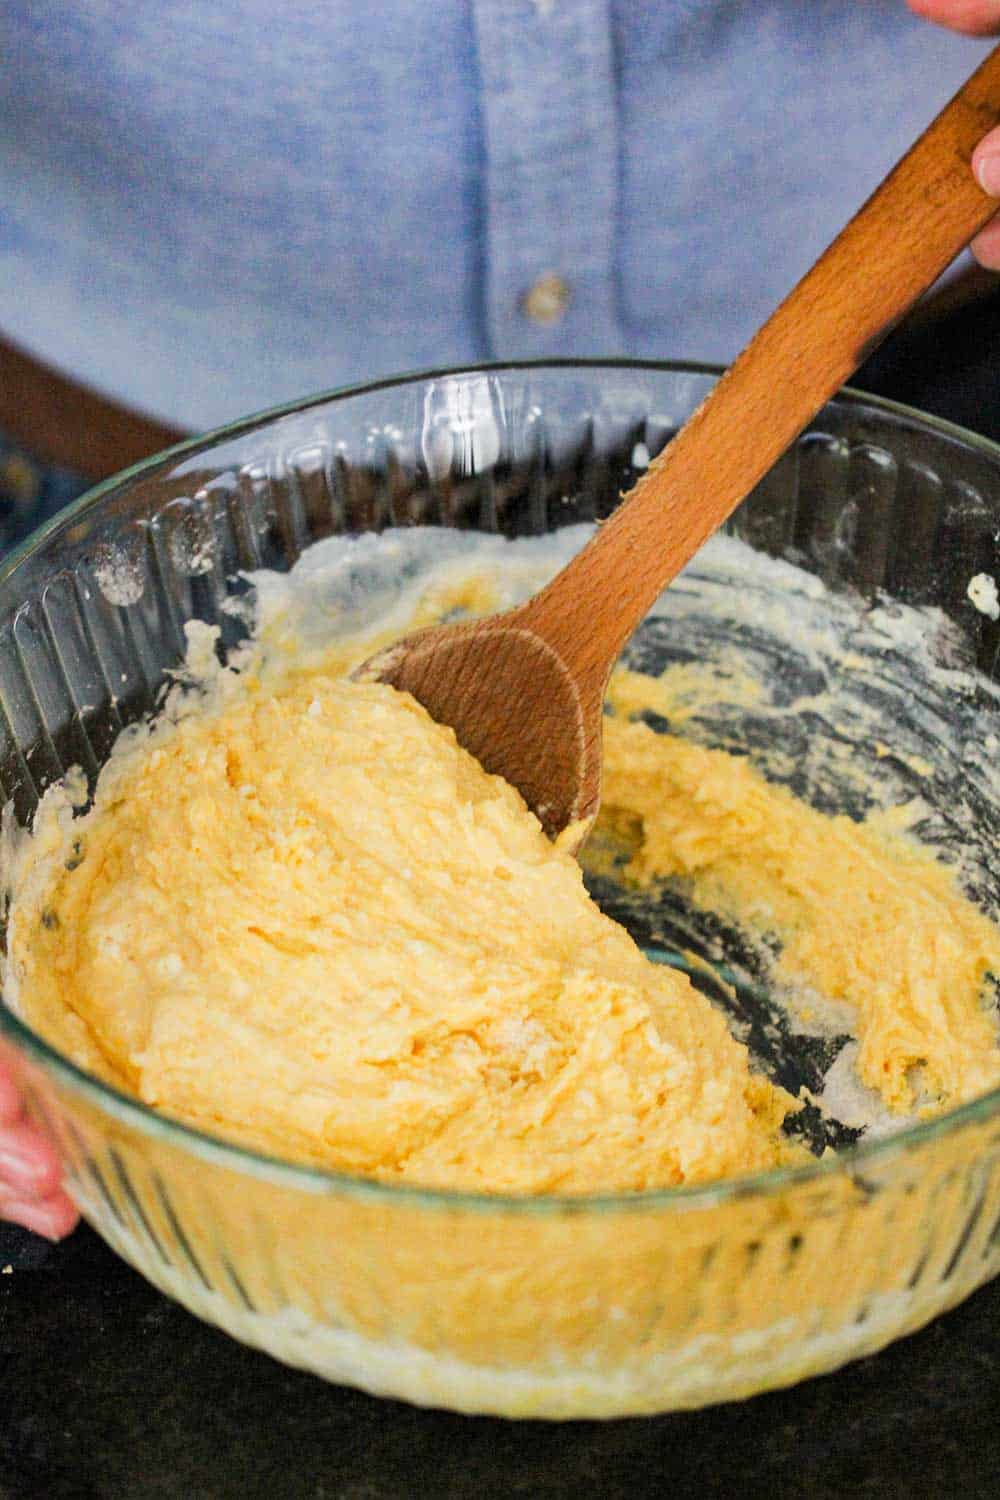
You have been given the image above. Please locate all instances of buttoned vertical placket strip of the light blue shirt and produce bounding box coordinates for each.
[474,0,622,359]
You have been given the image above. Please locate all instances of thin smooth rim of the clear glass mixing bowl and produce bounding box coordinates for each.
[0,359,1000,1217]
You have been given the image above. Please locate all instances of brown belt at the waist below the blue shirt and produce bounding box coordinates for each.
[0,266,997,480]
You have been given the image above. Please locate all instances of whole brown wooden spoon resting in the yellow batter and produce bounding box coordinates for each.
[364,48,1000,849]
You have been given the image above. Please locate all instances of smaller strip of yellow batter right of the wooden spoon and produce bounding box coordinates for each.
[603,672,1000,1110]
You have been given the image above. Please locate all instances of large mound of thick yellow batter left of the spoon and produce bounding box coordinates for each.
[3,672,790,1193]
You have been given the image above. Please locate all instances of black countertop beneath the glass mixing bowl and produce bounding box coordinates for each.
[0,1226,1000,1500]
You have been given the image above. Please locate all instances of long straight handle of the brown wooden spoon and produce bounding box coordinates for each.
[525,48,1000,693]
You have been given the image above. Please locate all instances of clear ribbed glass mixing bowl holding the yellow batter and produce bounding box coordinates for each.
[0,363,1000,1418]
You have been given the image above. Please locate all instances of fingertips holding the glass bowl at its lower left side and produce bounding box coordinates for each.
[0,1055,79,1239]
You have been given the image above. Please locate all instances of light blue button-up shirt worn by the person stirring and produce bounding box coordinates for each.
[0,0,984,428]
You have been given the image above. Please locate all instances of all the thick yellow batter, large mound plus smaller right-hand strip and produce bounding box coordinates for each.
[10,591,1000,1193]
